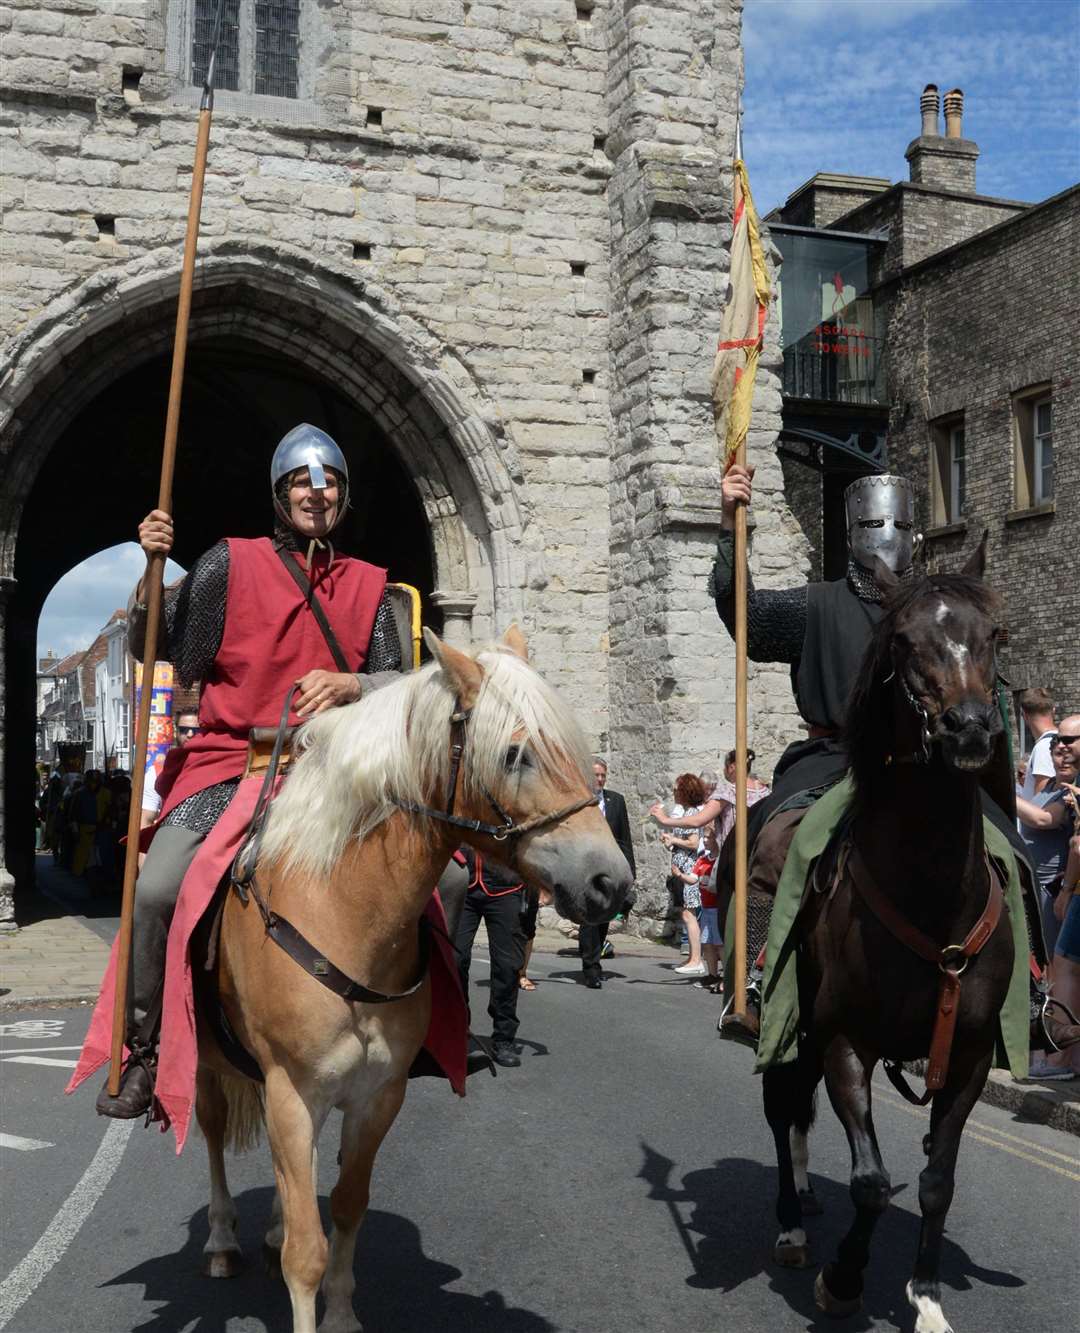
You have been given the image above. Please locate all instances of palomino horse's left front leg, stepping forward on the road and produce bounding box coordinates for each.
[267,1068,327,1333]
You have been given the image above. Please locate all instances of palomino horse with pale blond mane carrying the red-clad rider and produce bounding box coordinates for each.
[196,629,631,1333]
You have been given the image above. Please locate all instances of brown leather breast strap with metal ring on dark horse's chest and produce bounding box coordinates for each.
[847,844,1005,1106]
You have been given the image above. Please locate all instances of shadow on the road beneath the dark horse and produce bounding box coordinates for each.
[639,1142,1024,1333]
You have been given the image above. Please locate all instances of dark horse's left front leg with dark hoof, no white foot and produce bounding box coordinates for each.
[813,1037,889,1316]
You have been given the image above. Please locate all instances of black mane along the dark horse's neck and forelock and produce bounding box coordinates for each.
[844,575,999,806]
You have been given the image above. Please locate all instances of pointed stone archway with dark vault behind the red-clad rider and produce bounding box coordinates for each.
[0,265,513,892]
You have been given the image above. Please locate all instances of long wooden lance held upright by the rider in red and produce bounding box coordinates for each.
[108,31,224,1097]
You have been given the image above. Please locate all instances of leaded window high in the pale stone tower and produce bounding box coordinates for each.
[191,0,300,97]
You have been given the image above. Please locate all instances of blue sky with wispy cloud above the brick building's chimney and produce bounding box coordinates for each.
[743,0,1080,213]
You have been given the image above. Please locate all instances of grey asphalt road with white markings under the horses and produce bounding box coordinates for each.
[0,954,1080,1333]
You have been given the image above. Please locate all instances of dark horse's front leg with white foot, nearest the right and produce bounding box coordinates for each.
[908,1041,993,1333]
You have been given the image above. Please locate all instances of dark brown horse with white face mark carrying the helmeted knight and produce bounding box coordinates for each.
[764,547,1013,1333]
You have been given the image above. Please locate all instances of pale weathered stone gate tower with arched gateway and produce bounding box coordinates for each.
[0,0,804,914]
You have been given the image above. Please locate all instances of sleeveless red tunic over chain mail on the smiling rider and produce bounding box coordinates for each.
[157,537,387,816]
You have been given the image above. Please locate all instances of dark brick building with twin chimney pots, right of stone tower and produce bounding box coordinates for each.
[769,85,1080,745]
